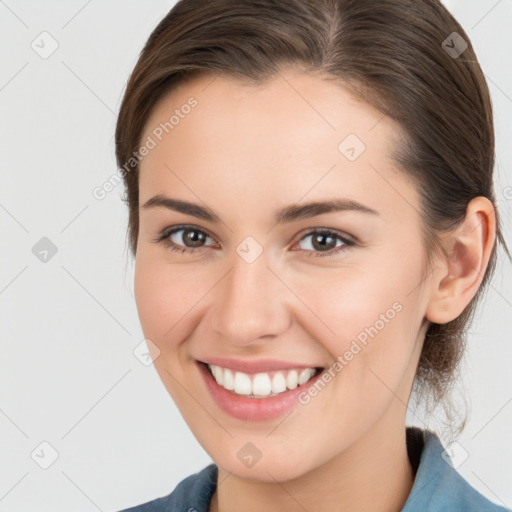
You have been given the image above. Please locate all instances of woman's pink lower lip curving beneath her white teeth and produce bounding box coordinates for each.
[198,362,321,421]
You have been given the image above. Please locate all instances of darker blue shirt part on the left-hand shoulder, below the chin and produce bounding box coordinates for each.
[120,464,217,512]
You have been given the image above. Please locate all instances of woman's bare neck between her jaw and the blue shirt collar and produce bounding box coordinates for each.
[210,411,414,512]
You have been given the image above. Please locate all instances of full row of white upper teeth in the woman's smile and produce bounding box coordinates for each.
[208,364,316,398]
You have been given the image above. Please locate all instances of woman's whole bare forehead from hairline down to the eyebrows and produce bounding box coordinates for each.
[140,70,416,222]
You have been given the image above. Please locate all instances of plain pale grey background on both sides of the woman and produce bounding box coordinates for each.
[0,0,512,512]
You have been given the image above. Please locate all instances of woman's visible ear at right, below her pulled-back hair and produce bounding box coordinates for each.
[426,196,496,324]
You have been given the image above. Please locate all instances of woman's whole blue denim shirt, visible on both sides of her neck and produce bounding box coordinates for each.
[121,427,510,512]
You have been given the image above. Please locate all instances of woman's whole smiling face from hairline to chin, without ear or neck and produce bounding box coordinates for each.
[135,70,436,481]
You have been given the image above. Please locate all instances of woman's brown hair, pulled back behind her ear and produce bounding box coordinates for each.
[115,0,510,436]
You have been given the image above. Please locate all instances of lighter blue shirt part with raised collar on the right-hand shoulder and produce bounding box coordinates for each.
[402,427,508,512]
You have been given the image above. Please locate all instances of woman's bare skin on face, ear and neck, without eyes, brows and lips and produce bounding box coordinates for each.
[135,69,495,512]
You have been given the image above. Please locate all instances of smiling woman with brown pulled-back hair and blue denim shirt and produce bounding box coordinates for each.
[116,0,510,512]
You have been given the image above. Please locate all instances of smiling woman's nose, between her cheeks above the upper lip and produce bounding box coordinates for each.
[211,249,293,346]
